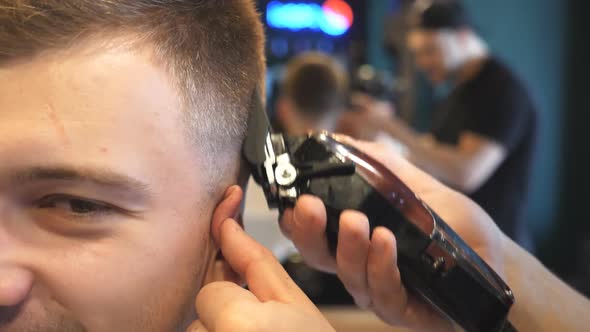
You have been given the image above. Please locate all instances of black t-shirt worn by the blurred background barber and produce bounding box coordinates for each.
[432,58,537,239]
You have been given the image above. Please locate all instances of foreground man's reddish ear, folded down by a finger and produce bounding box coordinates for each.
[205,185,244,284]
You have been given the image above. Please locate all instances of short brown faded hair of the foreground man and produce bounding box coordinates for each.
[0,0,265,179]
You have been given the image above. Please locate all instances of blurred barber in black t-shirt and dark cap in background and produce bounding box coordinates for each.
[350,1,537,244]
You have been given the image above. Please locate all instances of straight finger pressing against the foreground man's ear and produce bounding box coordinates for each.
[220,219,315,308]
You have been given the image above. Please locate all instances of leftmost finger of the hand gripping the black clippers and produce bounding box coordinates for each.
[281,195,336,273]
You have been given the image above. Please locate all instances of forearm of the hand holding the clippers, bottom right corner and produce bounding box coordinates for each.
[503,237,590,331]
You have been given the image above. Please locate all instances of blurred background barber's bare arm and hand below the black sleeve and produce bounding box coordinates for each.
[338,93,508,193]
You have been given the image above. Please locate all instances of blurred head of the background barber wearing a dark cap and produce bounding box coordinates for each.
[407,0,487,84]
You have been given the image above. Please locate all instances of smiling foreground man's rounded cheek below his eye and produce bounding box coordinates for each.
[63,220,211,331]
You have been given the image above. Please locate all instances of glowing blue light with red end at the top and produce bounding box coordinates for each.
[266,1,350,36]
